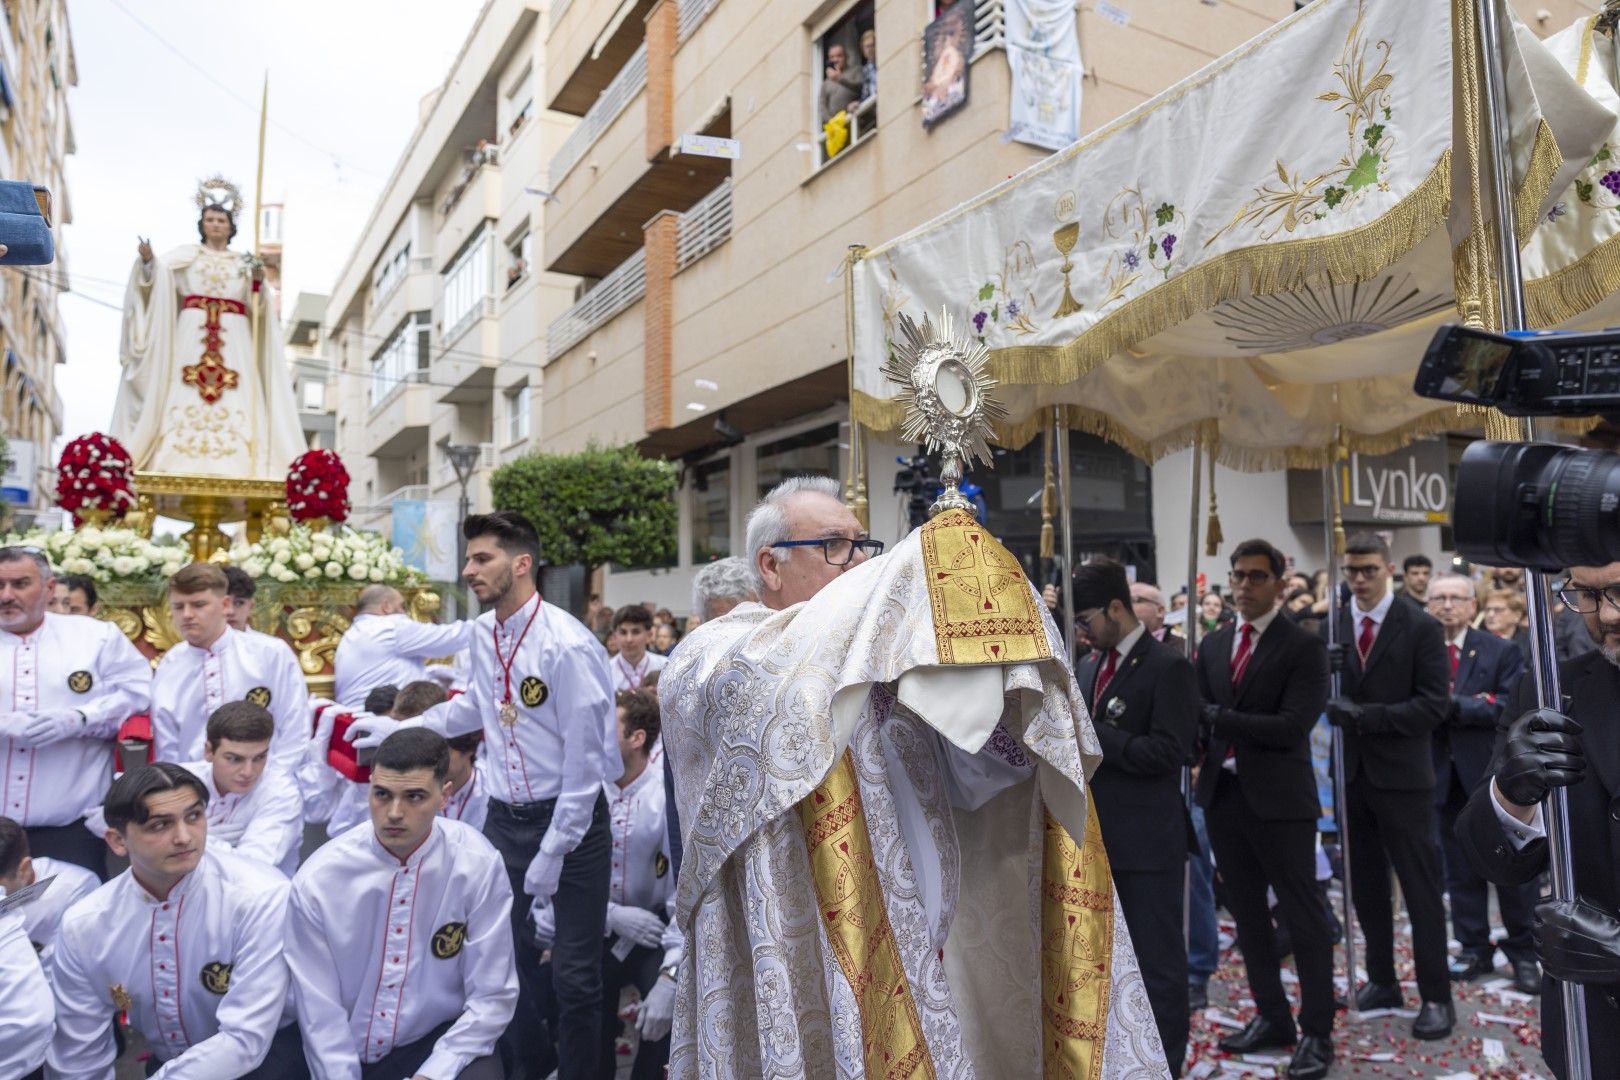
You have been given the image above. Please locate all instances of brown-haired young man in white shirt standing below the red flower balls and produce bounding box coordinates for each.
[152,562,309,776]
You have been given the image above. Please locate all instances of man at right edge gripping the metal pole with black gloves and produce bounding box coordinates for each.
[1456,562,1620,1080]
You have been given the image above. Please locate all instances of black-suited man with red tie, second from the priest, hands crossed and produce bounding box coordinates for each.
[1196,539,1333,1080]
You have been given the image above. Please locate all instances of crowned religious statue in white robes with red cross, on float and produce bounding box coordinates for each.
[112,176,306,479]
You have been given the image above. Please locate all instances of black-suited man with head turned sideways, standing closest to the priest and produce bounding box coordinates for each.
[1074,559,1199,1077]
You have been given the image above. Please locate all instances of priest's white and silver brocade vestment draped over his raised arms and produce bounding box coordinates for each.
[659,511,1166,1080]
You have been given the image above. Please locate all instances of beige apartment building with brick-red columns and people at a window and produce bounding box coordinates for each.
[541,0,1596,610]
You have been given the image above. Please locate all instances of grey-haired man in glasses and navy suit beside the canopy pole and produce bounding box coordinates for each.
[1429,573,1541,994]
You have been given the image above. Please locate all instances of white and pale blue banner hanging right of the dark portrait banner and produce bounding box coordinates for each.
[1006,0,1085,151]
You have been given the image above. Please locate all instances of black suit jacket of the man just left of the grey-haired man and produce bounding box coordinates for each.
[1322,596,1452,792]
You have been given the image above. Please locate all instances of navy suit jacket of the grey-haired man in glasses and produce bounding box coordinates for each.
[1434,630,1524,805]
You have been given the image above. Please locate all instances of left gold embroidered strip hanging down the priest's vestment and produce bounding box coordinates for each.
[799,750,935,1080]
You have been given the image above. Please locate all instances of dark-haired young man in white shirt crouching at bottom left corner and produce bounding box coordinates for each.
[45,761,308,1080]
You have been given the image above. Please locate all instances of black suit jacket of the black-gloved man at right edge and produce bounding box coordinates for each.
[1456,643,1620,1077]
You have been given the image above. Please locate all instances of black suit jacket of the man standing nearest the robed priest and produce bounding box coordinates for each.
[1074,633,1199,873]
